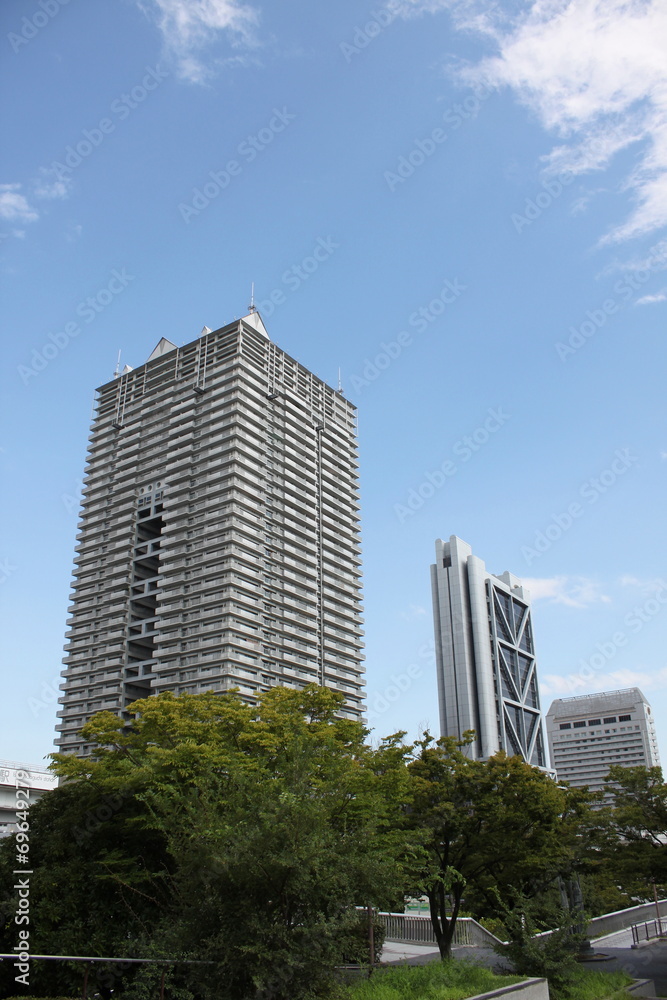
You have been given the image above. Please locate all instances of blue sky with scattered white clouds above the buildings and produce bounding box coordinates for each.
[0,0,667,763]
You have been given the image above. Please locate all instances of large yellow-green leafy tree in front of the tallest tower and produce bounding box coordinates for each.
[1,685,418,1000]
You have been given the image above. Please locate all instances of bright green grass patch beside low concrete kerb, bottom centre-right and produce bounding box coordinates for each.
[344,959,526,1000]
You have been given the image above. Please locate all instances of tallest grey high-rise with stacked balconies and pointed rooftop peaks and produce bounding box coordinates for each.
[57,309,364,753]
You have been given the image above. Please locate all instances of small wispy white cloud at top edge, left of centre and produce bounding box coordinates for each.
[138,0,258,83]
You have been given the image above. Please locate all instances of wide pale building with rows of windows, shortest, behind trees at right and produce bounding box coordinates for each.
[547,688,660,791]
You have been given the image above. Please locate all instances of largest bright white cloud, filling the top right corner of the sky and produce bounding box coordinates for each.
[393,0,667,242]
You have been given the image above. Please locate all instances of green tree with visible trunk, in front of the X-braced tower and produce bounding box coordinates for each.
[409,733,587,958]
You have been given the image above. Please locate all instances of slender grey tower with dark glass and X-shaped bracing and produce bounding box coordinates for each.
[431,535,548,769]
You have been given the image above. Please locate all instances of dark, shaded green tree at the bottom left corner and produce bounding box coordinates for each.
[0,778,170,996]
